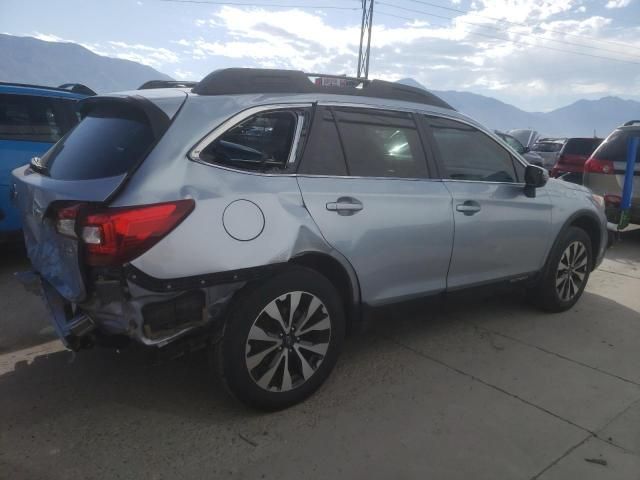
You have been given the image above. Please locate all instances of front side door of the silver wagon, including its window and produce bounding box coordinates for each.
[425,117,551,289]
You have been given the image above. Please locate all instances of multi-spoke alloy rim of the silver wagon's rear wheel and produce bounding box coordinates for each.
[245,291,331,392]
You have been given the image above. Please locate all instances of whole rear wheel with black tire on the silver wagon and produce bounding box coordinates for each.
[215,267,345,410]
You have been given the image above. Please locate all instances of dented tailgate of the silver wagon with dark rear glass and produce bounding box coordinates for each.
[13,97,180,302]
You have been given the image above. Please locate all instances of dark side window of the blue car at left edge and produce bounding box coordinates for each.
[0,94,78,143]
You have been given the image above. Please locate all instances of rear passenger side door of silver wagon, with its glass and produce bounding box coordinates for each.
[298,106,453,305]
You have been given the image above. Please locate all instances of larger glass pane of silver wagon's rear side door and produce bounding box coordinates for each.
[334,109,427,178]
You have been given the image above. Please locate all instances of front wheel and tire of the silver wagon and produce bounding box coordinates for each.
[530,227,593,312]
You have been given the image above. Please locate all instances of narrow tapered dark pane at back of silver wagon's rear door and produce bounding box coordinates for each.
[298,107,347,176]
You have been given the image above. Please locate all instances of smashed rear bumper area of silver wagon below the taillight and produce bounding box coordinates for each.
[15,271,245,350]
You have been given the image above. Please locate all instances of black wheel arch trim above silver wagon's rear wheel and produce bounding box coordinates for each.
[288,252,362,333]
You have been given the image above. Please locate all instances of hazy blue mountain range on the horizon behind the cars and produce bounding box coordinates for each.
[0,34,640,137]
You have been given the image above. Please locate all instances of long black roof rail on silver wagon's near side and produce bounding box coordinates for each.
[192,68,454,110]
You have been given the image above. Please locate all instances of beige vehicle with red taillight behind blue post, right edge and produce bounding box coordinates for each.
[583,120,640,225]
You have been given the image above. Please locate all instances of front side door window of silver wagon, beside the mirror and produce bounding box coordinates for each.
[427,117,518,182]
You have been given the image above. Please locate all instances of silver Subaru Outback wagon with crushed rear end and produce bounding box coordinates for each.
[13,69,607,409]
